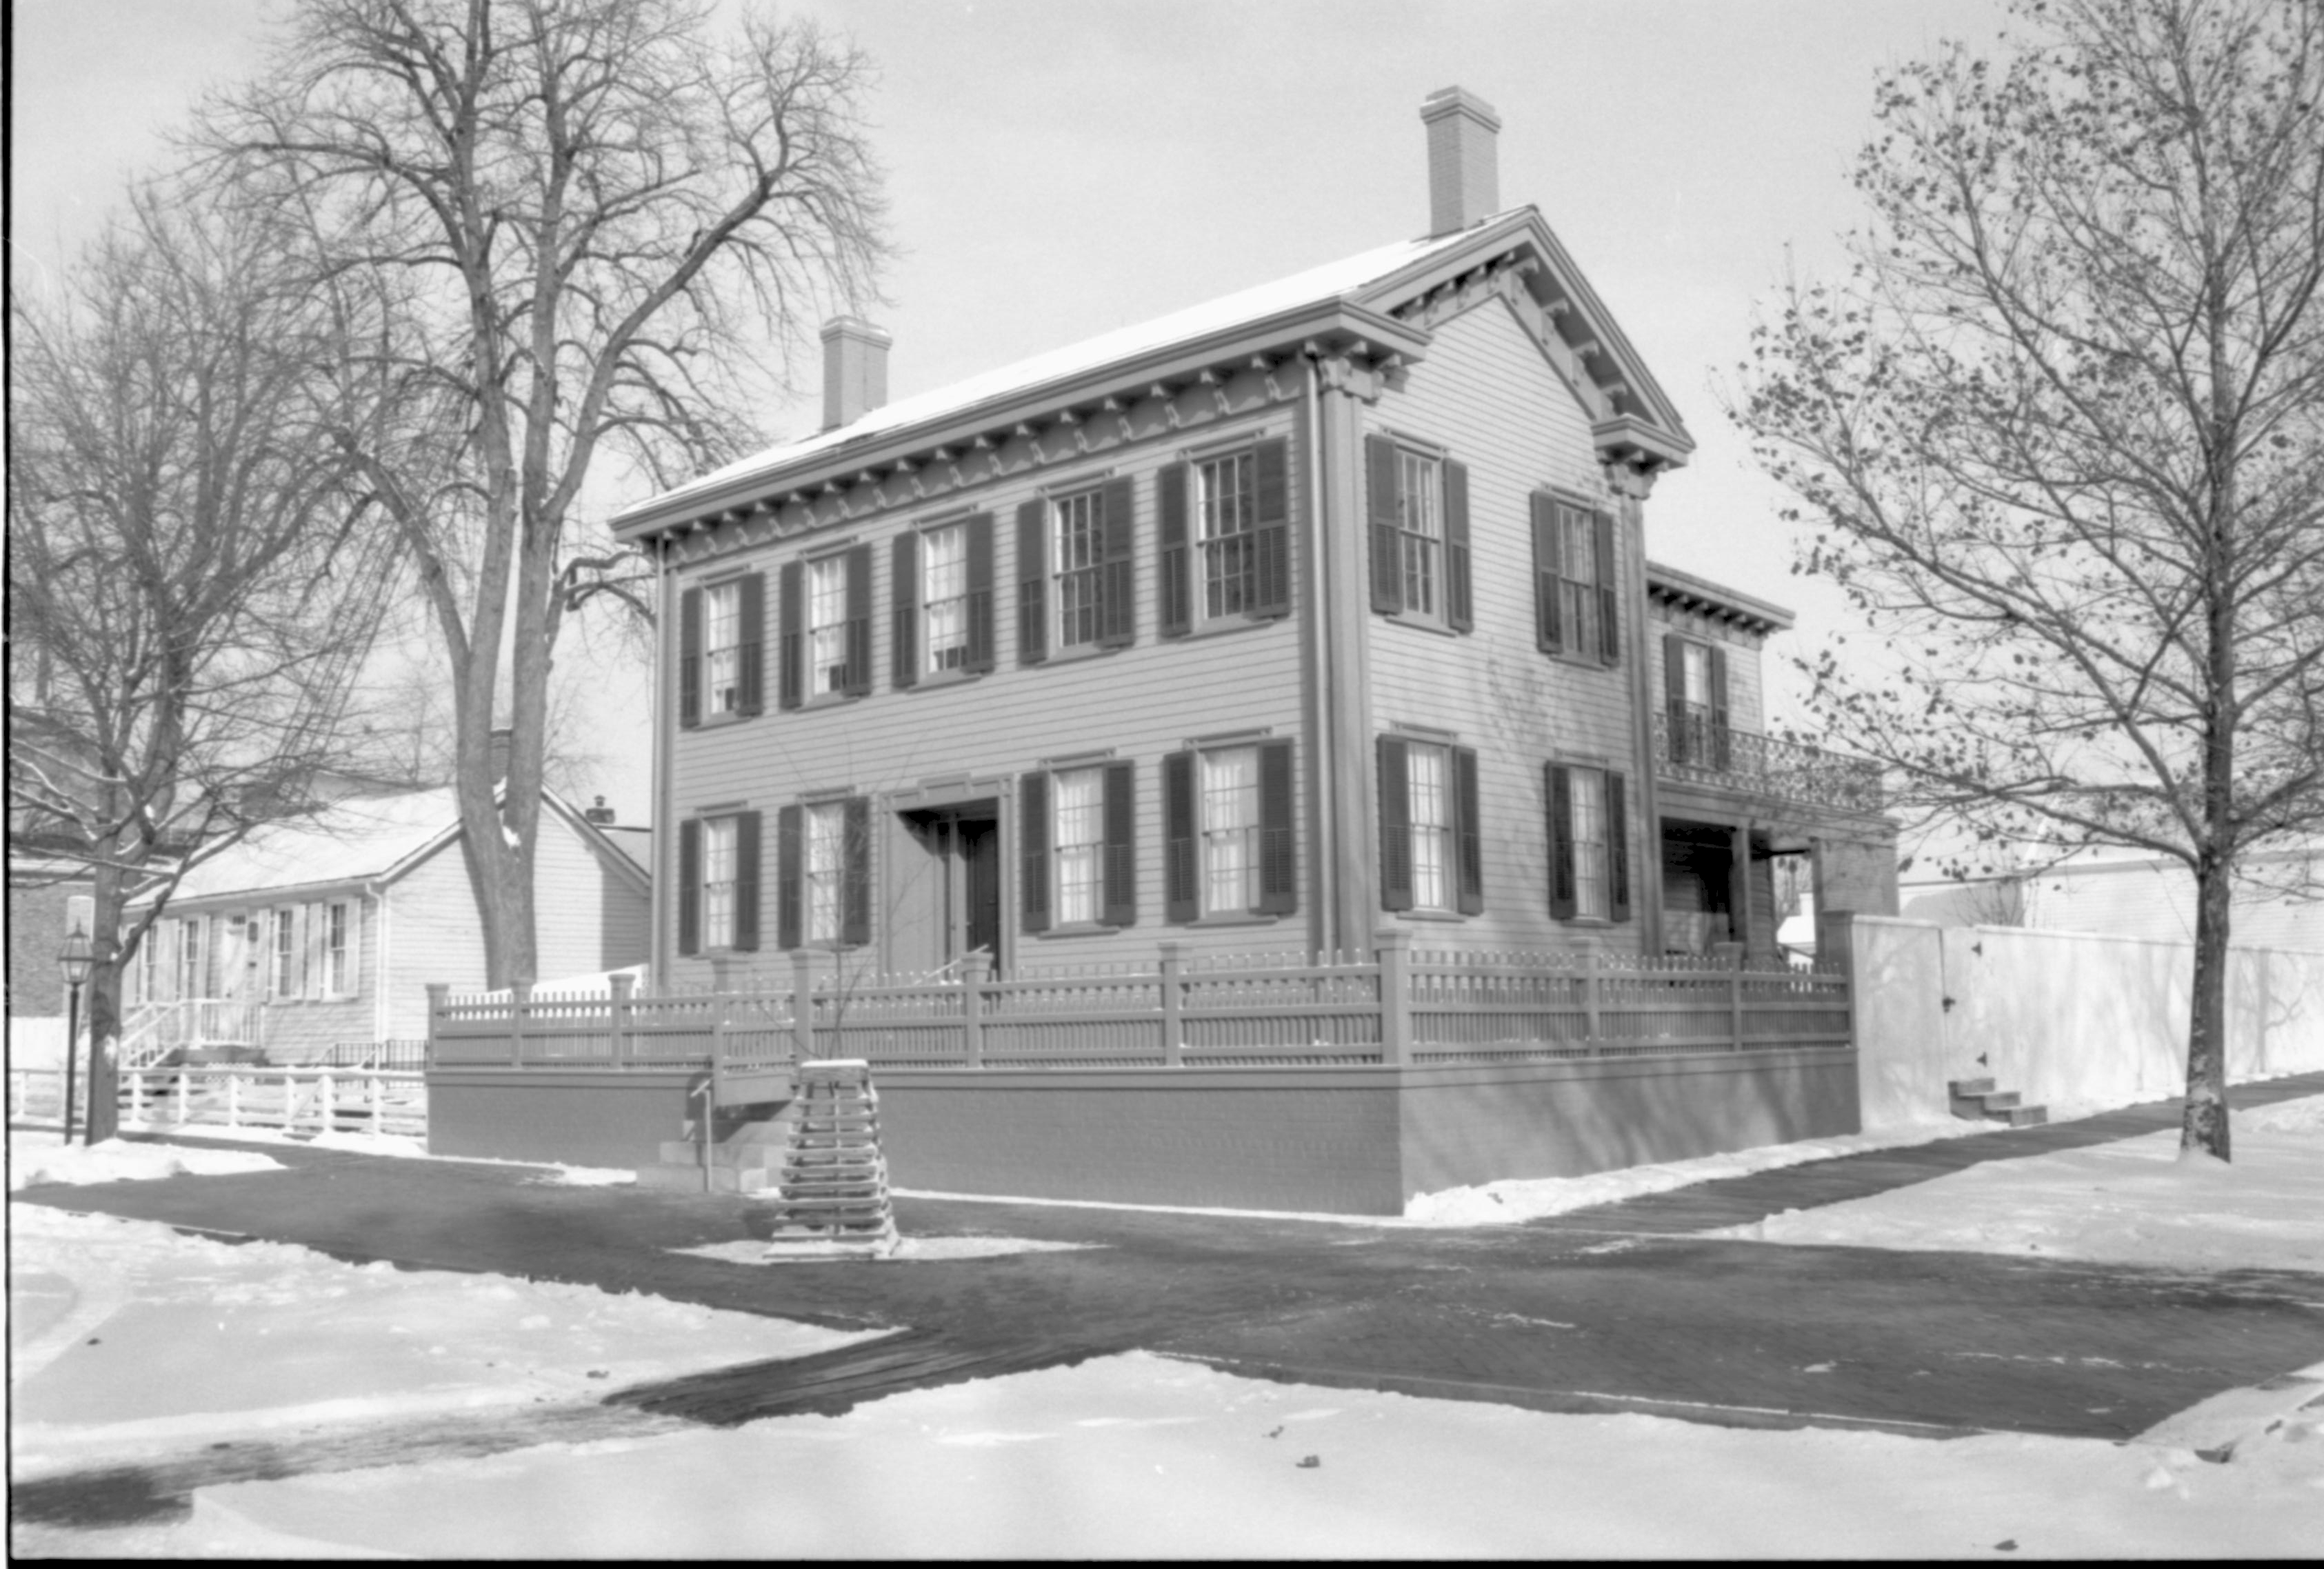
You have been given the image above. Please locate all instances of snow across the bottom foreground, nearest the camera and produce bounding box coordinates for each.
[19,1353,2324,1560]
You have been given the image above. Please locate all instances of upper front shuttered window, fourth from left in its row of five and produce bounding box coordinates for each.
[1018,479,1136,665]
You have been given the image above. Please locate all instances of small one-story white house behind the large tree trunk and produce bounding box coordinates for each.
[123,786,651,1062]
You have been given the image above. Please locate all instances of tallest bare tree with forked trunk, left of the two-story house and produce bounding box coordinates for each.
[197,0,885,986]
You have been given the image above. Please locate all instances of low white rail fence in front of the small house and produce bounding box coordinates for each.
[7,1062,428,1137]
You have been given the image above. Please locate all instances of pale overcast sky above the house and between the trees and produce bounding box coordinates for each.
[9,0,2001,821]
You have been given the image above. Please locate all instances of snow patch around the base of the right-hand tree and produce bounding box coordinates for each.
[1708,1095,2324,1273]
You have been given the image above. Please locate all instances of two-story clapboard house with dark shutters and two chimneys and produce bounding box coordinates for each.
[616,88,1894,986]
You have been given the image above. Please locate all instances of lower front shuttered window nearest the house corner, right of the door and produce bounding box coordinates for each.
[1162,741,1299,923]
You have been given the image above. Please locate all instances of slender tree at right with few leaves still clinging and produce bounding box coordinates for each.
[1734,0,2324,1157]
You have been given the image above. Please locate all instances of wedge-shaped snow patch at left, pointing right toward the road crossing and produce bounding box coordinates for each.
[9,1204,865,1471]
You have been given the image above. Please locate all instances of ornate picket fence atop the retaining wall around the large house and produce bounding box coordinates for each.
[428,932,1850,1072]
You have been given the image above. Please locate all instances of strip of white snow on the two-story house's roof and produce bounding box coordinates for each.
[616,217,1532,523]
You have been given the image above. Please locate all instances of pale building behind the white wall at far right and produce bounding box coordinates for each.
[1899,841,2324,953]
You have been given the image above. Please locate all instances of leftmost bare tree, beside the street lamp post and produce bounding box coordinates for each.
[7,188,395,1139]
